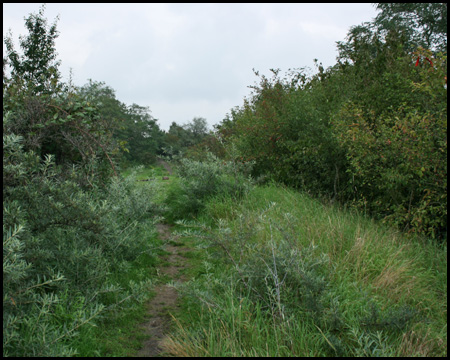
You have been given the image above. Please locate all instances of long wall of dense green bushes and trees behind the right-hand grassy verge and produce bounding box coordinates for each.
[218,4,447,238]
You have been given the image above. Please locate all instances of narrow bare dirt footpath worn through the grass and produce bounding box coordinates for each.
[137,224,190,357]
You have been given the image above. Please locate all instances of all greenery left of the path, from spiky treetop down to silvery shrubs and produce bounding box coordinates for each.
[3,8,160,357]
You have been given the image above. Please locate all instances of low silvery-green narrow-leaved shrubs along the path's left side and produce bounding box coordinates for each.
[3,123,162,356]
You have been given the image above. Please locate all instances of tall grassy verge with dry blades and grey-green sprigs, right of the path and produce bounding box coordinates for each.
[165,186,447,356]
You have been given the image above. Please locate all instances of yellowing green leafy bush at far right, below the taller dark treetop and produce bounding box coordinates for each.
[333,47,447,237]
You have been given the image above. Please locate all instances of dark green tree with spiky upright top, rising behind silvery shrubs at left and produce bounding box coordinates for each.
[3,7,119,186]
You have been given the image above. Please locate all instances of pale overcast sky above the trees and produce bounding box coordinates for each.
[3,3,377,130]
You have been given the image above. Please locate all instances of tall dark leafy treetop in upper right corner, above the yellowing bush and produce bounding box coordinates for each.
[337,3,447,118]
